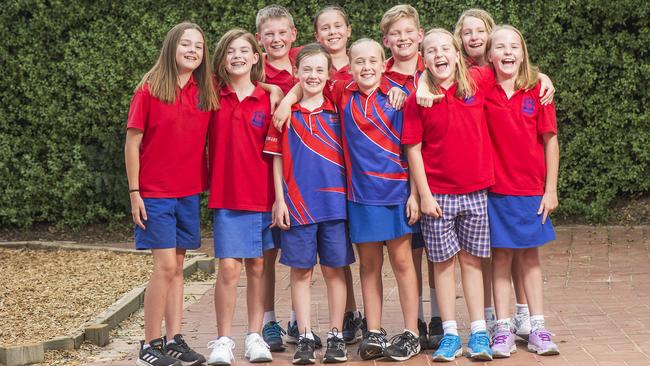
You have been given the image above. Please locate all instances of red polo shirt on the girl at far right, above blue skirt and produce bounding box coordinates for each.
[485,83,557,196]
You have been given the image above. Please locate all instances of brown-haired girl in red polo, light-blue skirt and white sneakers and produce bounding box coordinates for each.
[208,29,276,365]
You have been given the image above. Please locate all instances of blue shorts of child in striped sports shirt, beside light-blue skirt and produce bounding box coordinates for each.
[280,220,354,269]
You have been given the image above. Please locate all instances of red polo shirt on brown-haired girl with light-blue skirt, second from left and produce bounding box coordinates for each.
[208,86,275,212]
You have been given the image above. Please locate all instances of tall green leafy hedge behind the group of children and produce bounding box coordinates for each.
[0,0,650,228]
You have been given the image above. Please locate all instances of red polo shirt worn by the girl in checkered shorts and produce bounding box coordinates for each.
[402,67,494,194]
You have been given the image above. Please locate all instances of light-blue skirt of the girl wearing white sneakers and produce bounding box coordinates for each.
[213,209,280,258]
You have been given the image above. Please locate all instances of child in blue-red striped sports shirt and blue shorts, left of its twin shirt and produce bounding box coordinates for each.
[264,43,354,364]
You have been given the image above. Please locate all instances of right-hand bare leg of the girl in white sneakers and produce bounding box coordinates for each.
[244,257,264,333]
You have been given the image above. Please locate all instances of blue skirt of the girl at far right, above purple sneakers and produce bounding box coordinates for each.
[488,193,555,249]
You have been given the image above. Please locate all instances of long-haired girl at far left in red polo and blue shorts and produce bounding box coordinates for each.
[124,23,218,366]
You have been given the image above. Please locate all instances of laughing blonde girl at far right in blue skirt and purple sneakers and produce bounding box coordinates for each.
[485,25,560,357]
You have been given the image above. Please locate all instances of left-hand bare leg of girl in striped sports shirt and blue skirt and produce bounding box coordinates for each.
[357,242,384,330]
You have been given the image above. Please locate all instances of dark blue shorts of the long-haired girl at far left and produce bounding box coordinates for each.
[135,194,201,249]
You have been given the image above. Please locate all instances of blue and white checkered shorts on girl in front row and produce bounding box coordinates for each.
[421,190,490,262]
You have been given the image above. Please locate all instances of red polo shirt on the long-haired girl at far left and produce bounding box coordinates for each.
[126,77,211,198]
